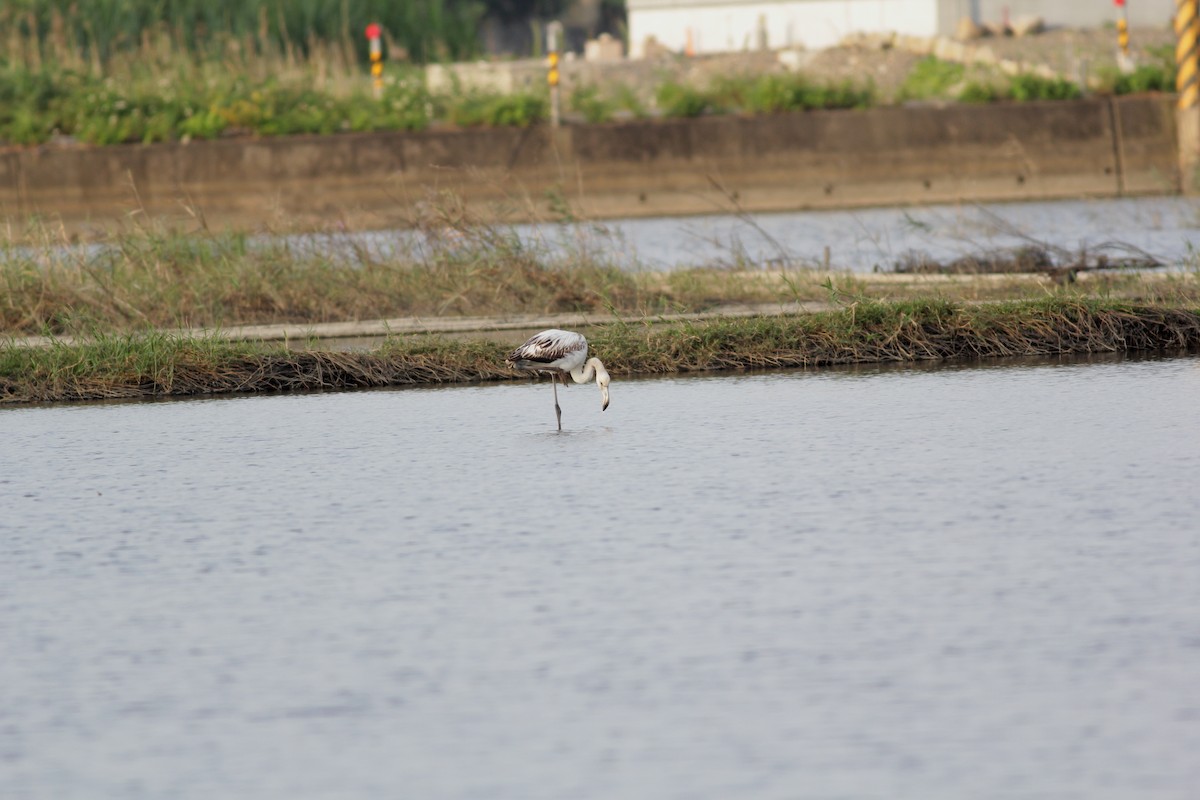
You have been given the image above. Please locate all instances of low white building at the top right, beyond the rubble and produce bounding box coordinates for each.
[625,0,1175,58]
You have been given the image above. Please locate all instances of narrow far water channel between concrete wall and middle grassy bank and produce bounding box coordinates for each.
[319,197,1200,272]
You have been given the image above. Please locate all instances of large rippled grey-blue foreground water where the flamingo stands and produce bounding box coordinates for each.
[0,357,1200,800]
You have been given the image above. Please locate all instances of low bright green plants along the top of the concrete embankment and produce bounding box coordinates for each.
[0,42,1175,145]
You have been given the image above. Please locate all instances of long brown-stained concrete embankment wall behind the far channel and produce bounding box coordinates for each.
[0,96,1180,231]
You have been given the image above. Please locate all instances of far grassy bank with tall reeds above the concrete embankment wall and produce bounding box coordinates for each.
[0,19,1175,145]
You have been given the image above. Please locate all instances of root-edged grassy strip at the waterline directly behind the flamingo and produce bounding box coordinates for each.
[0,299,1200,403]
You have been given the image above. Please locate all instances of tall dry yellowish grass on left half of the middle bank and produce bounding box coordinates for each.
[0,210,670,335]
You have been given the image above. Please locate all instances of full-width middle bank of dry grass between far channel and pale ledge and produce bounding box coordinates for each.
[0,215,1200,336]
